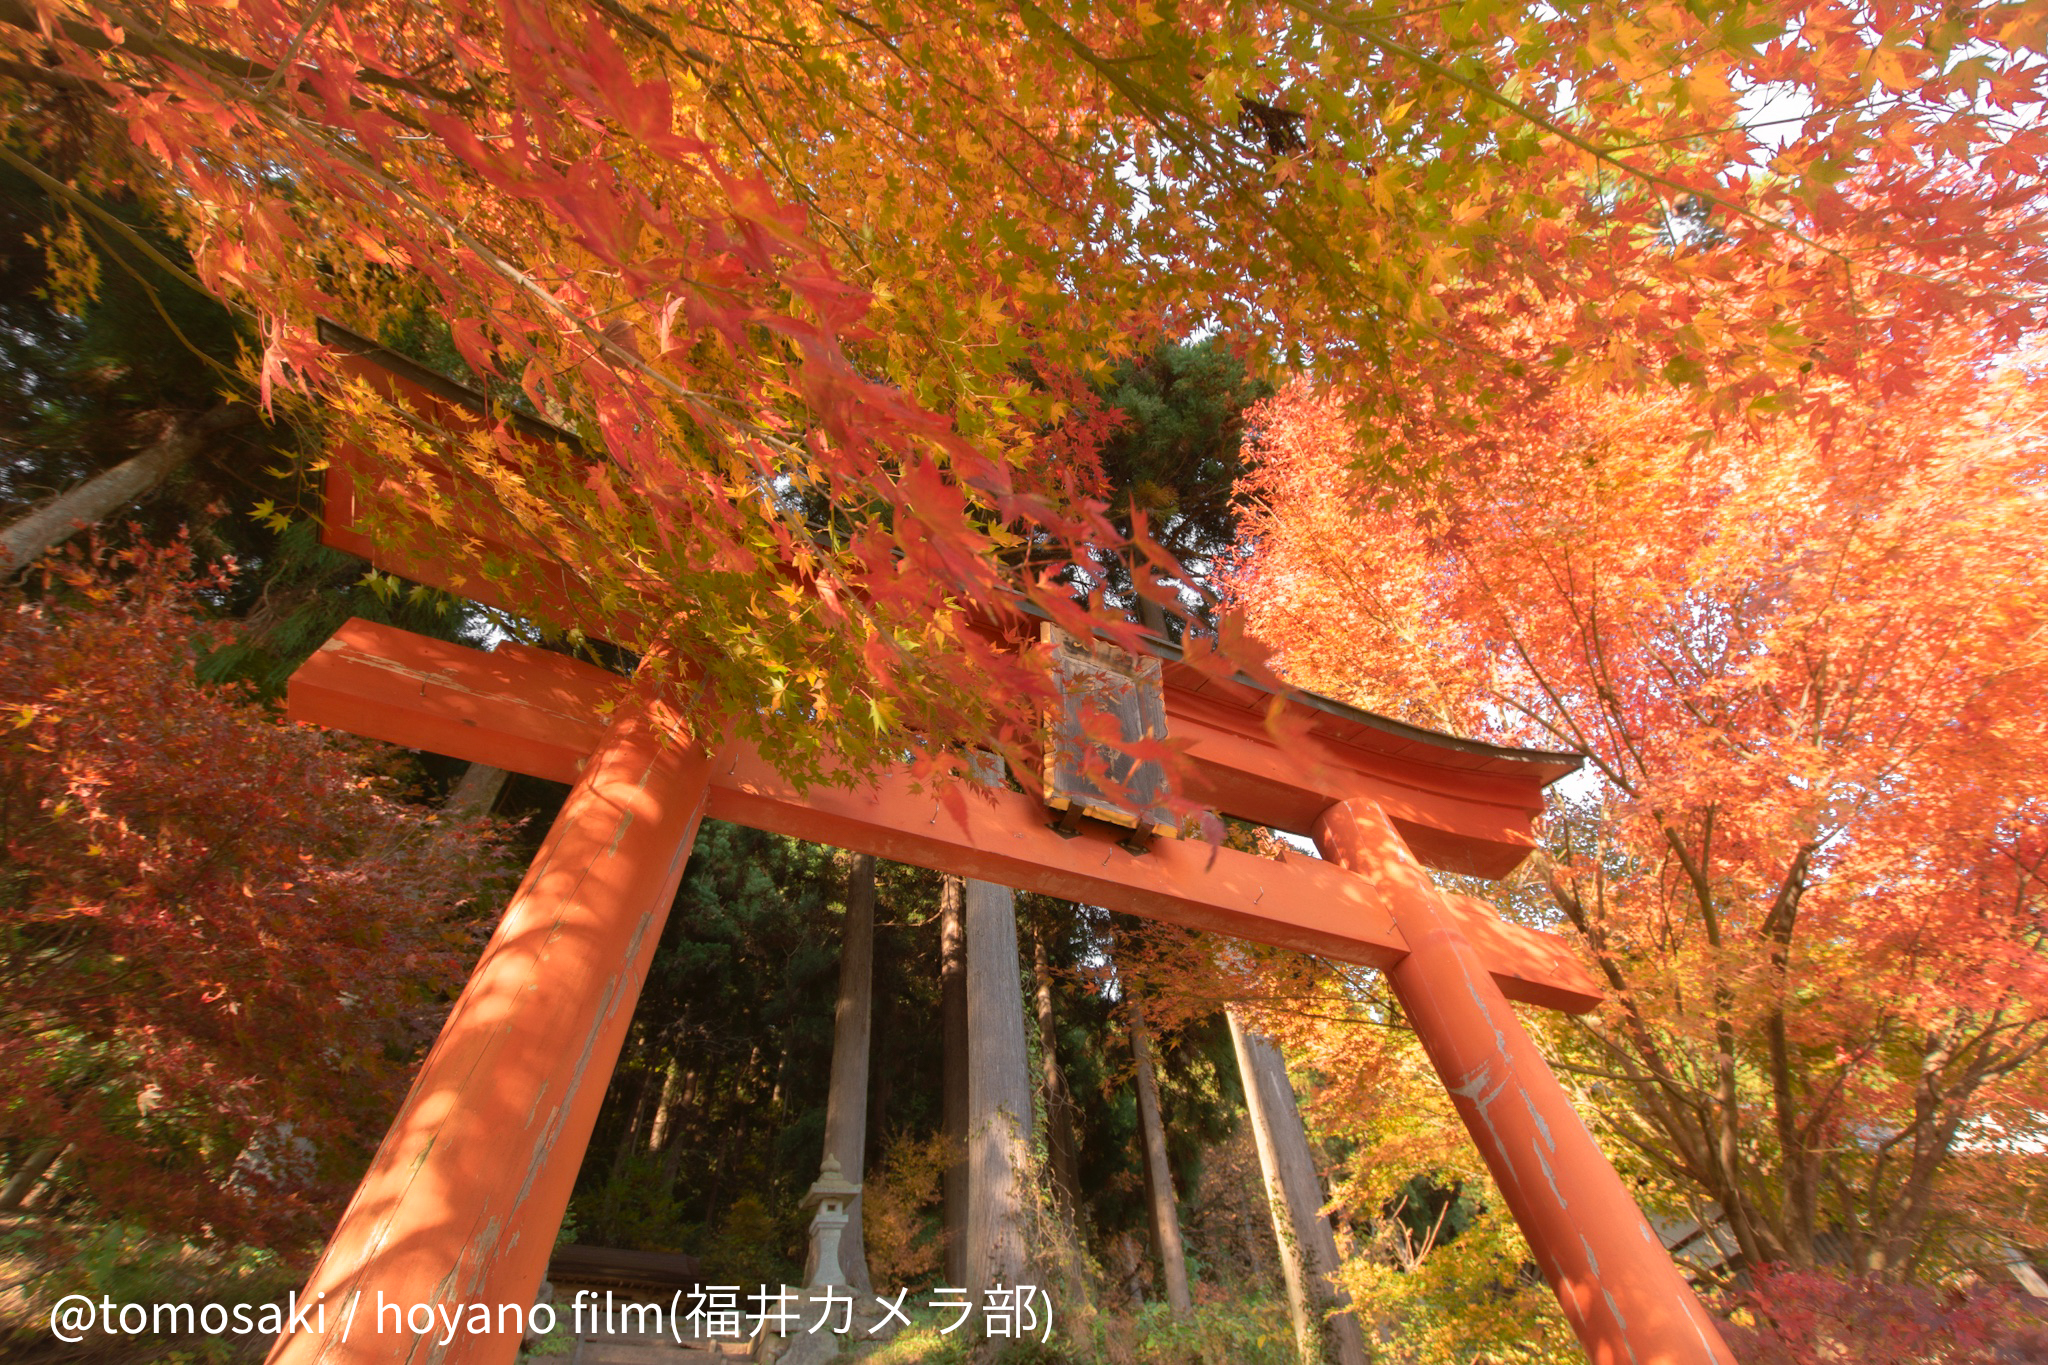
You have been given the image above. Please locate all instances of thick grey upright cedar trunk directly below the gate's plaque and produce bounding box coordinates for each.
[961,880,1032,1302]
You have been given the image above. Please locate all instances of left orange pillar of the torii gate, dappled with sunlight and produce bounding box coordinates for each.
[270,698,711,1365]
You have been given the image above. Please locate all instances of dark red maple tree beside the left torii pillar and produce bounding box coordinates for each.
[0,544,504,1248]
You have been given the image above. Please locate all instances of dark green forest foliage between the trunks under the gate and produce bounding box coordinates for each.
[571,875,1241,1283]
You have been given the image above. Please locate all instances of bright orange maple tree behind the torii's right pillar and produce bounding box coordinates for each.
[1231,329,2048,1277]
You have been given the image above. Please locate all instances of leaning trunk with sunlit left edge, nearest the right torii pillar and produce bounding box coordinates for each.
[1229,1011,1366,1365]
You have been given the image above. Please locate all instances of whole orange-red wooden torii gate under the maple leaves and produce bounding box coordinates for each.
[270,329,1733,1365]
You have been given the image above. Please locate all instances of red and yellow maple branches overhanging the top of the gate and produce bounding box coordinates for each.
[0,0,2044,789]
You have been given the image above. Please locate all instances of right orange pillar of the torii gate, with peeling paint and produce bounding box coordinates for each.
[1315,800,1735,1365]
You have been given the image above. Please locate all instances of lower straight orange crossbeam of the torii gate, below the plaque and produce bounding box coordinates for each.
[287,620,1602,1013]
